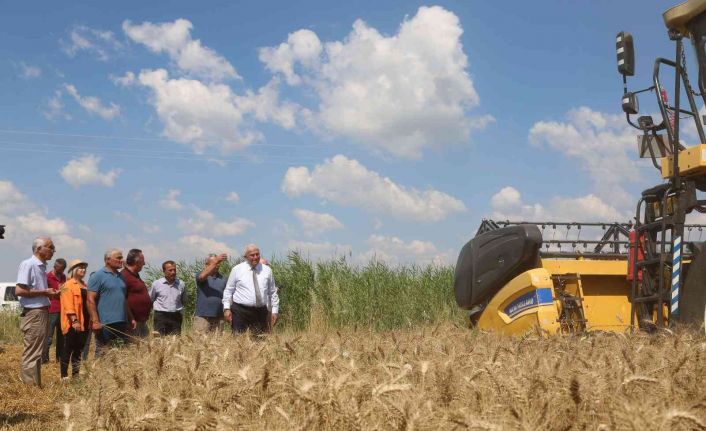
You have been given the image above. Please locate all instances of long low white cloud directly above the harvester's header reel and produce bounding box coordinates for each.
[490,186,632,223]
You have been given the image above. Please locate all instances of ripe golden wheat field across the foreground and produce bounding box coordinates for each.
[0,324,706,430]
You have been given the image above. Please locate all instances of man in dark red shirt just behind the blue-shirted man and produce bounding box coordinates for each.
[120,248,152,338]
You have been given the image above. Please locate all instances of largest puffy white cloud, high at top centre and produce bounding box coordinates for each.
[259,6,484,158]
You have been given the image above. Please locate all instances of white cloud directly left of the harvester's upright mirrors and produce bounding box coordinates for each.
[529,107,640,206]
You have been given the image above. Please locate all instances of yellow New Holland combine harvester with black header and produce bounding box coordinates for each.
[454,0,706,334]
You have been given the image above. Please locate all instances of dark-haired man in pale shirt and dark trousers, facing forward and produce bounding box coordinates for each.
[150,260,186,335]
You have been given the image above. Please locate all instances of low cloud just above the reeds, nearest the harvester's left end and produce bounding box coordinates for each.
[358,235,456,265]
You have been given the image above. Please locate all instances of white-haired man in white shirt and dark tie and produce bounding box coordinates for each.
[223,244,279,334]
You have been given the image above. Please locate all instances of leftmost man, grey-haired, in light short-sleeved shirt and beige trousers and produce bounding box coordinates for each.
[15,237,59,386]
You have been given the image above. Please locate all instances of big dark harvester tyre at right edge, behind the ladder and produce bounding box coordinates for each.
[679,241,706,327]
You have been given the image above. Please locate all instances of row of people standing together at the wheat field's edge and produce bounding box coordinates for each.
[16,237,279,385]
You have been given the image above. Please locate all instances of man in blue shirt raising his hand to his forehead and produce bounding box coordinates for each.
[194,253,228,332]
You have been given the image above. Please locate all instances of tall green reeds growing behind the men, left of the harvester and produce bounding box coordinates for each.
[145,252,461,330]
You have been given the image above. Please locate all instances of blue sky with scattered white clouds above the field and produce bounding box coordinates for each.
[0,1,697,279]
